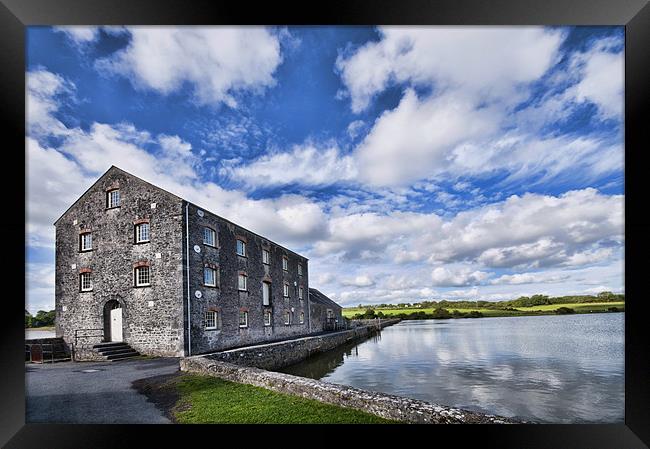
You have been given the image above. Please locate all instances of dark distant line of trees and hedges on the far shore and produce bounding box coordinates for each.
[358,292,625,310]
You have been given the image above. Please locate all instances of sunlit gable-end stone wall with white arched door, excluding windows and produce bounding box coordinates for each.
[55,167,184,356]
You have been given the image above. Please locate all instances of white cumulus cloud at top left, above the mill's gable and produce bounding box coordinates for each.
[96,26,282,107]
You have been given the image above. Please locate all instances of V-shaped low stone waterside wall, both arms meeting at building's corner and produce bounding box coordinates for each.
[180,319,520,424]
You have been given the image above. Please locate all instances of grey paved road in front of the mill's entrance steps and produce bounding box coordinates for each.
[25,358,179,424]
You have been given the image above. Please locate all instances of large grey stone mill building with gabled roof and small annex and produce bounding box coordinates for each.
[54,166,343,356]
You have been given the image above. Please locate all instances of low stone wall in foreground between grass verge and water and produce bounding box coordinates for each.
[180,356,516,424]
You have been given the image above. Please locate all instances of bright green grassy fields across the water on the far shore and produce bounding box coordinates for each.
[343,302,625,318]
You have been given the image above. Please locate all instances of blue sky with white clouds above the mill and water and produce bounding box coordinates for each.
[26,27,624,311]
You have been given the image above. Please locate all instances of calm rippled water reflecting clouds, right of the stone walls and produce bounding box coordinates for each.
[283,313,625,423]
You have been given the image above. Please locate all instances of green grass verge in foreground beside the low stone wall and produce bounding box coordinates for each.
[172,374,395,424]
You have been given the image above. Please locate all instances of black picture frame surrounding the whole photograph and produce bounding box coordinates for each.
[0,0,650,448]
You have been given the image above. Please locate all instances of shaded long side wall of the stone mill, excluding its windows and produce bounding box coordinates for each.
[184,204,309,354]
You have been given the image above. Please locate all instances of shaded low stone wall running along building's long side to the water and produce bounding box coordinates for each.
[200,319,399,370]
